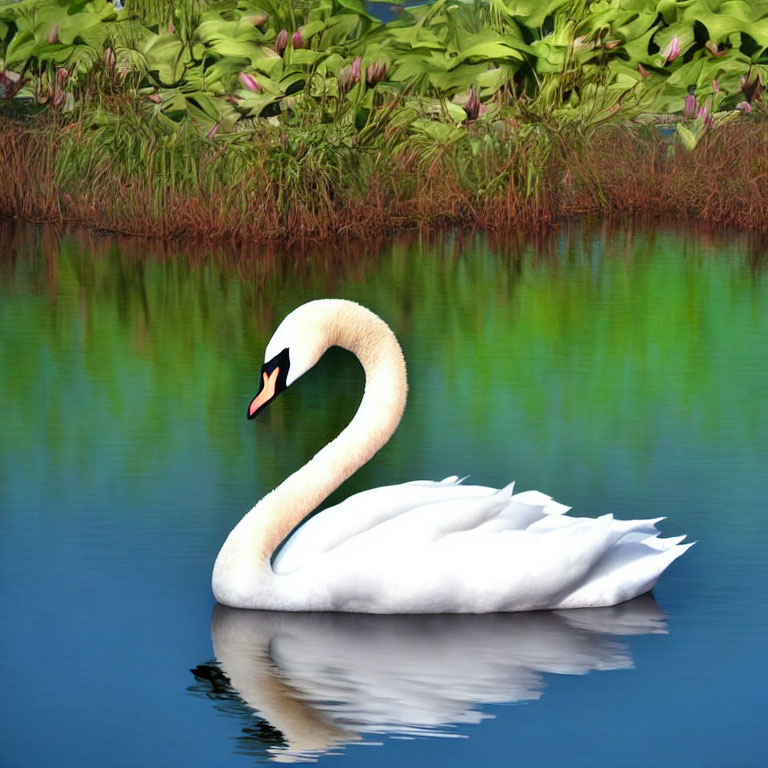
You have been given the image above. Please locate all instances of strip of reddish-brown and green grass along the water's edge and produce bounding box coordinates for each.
[0,113,768,243]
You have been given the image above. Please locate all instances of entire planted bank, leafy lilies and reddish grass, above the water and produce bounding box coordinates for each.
[0,0,768,243]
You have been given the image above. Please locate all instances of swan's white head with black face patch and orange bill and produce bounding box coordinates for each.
[248,299,332,419]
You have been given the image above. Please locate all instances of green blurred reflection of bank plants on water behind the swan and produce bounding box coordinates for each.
[0,219,768,520]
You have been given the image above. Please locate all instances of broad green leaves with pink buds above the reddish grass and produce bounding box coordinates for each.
[0,0,768,139]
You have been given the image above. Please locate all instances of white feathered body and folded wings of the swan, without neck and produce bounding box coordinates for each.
[273,475,690,613]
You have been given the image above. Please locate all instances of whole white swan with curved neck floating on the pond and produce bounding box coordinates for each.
[212,299,691,613]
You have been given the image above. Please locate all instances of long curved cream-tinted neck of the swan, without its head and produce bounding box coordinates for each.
[213,302,408,605]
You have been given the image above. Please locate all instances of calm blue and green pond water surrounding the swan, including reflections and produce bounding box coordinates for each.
[0,225,768,768]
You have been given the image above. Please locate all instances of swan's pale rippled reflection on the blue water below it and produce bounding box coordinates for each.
[195,595,666,760]
